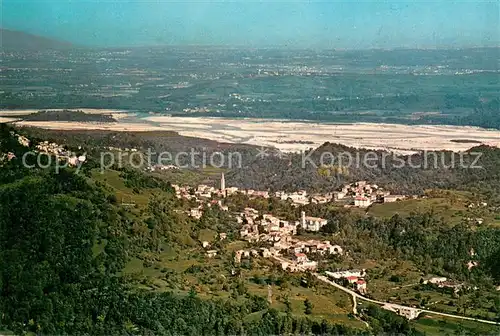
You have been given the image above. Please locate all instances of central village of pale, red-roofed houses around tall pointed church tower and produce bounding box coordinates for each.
[172,173,420,300]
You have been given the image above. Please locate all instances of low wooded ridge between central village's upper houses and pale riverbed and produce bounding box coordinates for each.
[227,143,500,202]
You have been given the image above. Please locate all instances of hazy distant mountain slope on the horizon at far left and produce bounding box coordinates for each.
[0,28,73,51]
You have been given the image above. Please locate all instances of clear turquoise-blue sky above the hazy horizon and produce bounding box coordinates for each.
[1,0,500,49]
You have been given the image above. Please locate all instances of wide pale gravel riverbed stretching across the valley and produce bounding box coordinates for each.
[7,109,500,154]
